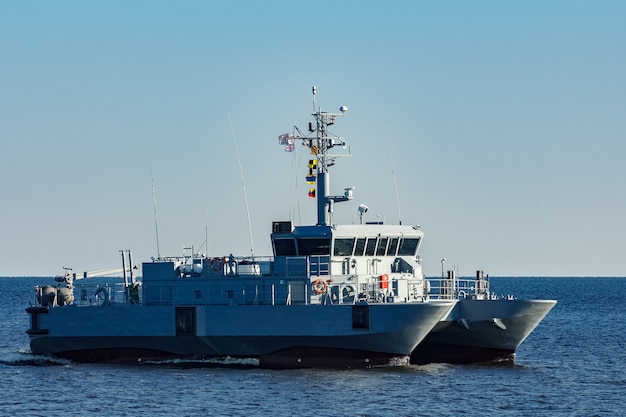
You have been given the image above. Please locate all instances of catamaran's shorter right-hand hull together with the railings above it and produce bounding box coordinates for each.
[411,272,556,364]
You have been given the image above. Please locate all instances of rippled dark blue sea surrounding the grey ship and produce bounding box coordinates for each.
[0,277,626,417]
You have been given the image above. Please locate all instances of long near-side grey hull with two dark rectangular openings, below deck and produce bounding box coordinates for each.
[29,302,453,368]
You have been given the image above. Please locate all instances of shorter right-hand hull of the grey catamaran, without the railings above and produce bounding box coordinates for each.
[411,299,556,364]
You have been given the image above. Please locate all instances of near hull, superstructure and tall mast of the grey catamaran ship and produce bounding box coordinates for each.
[26,87,457,368]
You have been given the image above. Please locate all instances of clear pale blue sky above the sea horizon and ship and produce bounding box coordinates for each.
[0,0,626,276]
